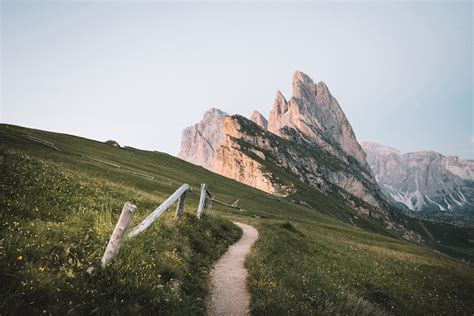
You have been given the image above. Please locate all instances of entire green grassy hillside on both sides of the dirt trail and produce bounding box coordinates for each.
[0,125,474,314]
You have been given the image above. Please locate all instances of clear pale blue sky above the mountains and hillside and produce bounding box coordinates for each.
[0,0,474,159]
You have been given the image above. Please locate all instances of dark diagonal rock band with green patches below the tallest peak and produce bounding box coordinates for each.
[230,116,388,211]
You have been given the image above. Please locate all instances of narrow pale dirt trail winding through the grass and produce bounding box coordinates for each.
[206,222,258,315]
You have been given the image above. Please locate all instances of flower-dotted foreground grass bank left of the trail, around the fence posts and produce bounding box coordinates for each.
[0,151,241,314]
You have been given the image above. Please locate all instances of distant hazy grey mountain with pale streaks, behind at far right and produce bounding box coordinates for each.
[363,142,474,213]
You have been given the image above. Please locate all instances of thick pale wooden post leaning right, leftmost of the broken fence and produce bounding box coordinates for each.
[100,202,137,268]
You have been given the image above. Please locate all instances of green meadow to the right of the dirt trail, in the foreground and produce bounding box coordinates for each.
[248,223,474,315]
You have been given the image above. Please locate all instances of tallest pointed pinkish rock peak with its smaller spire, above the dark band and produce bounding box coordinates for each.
[268,71,372,173]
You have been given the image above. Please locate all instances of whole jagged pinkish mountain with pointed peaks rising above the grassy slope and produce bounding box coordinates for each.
[178,71,388,218]
